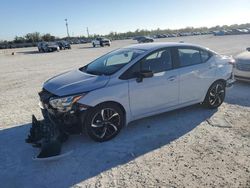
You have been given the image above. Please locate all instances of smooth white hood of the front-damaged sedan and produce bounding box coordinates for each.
[43,70,109,96]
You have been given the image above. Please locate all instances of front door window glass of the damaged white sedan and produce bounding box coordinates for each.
[141,49,172,73]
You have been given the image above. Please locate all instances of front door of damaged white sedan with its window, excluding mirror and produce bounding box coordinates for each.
[128,48,179,117]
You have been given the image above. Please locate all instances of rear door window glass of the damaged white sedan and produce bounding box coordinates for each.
[178,48,203,67]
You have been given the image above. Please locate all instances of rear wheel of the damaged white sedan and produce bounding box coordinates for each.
[203,81,226,109]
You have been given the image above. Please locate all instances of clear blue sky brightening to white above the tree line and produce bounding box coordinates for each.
[0,0,250,40]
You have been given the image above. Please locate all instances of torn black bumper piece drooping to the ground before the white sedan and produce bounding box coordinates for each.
[25,115,67,158]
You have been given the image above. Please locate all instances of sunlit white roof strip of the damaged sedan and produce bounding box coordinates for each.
[125,42,208,51]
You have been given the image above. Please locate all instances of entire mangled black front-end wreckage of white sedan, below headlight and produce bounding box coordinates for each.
[25,90,87,158]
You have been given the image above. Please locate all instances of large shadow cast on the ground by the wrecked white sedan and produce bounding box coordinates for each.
[0,105,216,188]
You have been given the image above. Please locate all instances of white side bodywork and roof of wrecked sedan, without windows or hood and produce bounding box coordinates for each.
[78,43,234,124]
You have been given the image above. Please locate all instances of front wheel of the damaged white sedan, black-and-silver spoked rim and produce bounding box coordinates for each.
[84,103,125,142]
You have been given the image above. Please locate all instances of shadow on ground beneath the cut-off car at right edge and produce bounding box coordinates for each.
[225,81,250,107]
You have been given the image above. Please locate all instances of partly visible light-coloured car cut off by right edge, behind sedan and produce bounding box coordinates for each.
[234,48,250,81]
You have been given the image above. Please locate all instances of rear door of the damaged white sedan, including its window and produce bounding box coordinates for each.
[176,47,216,104]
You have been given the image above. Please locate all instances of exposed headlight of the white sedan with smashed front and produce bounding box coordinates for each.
[49,94,85,112]
